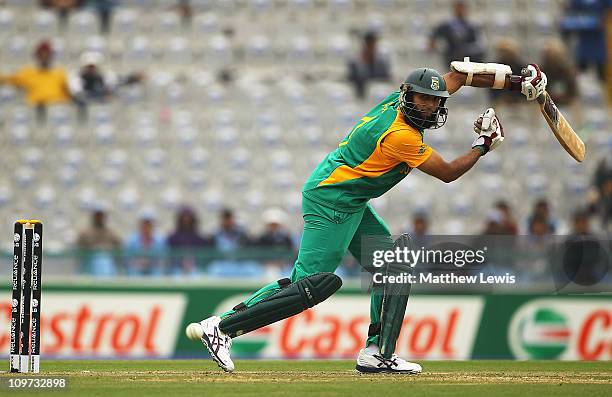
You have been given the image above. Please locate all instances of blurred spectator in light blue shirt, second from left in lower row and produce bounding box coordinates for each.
[124,213,166,276]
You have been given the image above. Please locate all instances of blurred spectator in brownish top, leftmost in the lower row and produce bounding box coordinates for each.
[77,209,121,277]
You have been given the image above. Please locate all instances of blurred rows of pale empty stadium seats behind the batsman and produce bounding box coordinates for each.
[0,0,612,249]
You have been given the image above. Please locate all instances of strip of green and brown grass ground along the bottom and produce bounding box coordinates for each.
[0,360,612,397]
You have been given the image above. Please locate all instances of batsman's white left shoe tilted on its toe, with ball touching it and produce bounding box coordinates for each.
[185,316,234,372]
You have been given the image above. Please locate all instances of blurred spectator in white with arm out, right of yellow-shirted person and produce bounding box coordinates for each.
[68,51,142,105]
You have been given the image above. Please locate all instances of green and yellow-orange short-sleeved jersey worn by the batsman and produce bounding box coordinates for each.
[303,91,432,212]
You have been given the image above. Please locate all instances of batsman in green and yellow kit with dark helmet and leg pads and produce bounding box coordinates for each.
[186,59,546,374]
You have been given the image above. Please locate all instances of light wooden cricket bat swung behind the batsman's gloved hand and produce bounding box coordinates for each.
[527,68,586,162]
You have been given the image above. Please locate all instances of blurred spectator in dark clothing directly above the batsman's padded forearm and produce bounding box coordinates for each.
[429,1,484,67]
